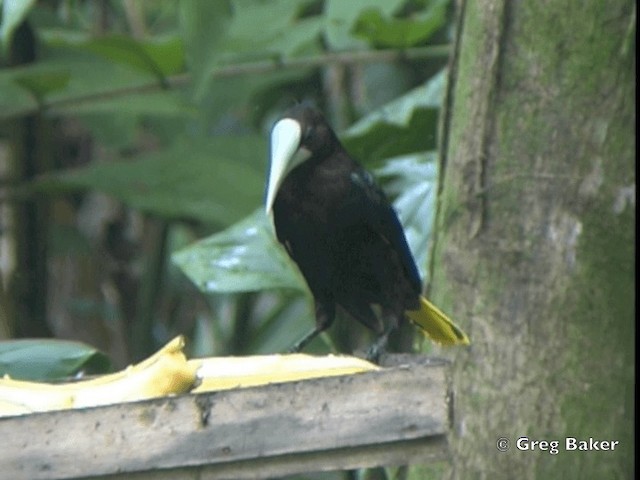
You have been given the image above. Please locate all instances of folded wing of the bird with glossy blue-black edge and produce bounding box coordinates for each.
[348,168,422,294]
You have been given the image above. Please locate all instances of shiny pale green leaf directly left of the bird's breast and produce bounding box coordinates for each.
[172,209,306,293]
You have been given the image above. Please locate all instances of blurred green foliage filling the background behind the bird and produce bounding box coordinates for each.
[0,0,448,368]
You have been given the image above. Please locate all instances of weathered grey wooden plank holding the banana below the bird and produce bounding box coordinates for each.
[0,356,449,479]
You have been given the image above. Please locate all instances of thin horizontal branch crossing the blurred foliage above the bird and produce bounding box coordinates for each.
[6,45,449,119]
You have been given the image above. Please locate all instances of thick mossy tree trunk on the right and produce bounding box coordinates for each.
[430,0,636,479]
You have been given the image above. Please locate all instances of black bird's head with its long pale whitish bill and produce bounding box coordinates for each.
[265,103,339,214]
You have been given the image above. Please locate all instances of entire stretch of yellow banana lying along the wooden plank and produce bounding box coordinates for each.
[0,336,378,417]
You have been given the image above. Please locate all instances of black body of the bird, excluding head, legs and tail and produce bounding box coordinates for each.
[273,153,420,318]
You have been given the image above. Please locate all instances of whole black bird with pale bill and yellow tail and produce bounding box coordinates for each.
[265,104,469,358]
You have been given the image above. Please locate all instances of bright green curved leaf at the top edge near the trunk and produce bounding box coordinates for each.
[352,0,447,48]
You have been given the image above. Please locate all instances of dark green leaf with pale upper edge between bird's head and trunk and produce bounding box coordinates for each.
[341,71,446,166]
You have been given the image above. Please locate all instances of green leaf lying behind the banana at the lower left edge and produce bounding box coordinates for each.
[0,339,110,380]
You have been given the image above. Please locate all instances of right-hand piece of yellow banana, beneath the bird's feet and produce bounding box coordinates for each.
[189,353,378,393]
